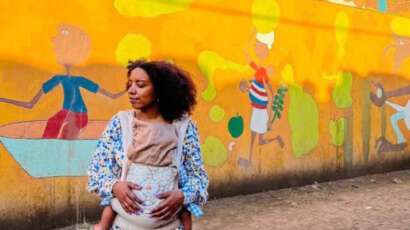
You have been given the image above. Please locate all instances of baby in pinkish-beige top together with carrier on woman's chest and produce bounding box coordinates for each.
[94,112,192,230]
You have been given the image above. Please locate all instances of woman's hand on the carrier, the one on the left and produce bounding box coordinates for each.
[112,181,142,213]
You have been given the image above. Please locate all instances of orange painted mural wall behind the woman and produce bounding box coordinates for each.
[0,0,410,228]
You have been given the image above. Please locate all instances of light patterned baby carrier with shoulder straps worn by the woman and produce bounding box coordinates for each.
[111,111,189,230]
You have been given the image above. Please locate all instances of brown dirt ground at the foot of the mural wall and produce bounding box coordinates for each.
[60,170,410,230]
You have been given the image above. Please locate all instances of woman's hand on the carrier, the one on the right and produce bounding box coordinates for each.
[151,189,184,220]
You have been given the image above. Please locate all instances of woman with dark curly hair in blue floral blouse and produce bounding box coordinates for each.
[88,61,208,229]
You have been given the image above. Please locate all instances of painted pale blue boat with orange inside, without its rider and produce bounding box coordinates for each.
[0,121,107,178]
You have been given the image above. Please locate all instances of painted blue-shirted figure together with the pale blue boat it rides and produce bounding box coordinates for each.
[0,25,125,177]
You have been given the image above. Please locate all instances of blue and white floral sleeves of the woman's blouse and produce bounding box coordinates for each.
[87,116,209,217]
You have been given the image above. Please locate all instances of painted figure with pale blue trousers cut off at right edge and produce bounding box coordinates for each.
[370,82,410,153]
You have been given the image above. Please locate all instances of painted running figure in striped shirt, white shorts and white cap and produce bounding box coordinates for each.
[238,32,284,167]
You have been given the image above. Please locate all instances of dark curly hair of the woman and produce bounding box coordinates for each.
[127,60,196,122]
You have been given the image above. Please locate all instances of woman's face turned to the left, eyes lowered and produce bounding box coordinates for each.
[127,68,156,109]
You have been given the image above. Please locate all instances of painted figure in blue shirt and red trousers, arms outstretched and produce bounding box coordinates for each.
[0,25,125,139]
